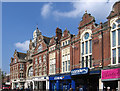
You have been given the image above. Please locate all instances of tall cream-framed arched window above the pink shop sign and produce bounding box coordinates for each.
[111,19,120,64]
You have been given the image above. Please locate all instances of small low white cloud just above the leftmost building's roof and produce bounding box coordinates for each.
[15,40,30,51]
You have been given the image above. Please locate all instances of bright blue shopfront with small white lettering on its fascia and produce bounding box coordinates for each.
[49,74,71,91]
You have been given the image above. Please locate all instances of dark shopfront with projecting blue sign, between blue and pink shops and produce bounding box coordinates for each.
[71,67,100,91]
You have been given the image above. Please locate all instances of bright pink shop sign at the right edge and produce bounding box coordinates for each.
[102,68,120,80]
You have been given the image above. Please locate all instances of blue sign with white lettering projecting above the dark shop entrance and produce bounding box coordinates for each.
[71,67,88,75]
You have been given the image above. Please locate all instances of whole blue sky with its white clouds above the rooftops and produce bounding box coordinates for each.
[2,0,115,73]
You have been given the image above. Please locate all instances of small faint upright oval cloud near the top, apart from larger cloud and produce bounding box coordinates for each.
[41,3,52,18]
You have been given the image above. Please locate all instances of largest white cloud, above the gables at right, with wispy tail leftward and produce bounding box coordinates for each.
[53,0,116,18]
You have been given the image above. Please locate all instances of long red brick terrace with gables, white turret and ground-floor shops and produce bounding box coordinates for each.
[11,1,120,91]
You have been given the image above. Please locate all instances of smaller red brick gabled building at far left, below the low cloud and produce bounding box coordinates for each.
[10,50,27,89]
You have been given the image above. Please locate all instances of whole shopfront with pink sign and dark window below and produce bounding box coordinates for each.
[101,68,120,91]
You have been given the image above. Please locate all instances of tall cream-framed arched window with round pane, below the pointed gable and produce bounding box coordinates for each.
[81,30,92,68]
